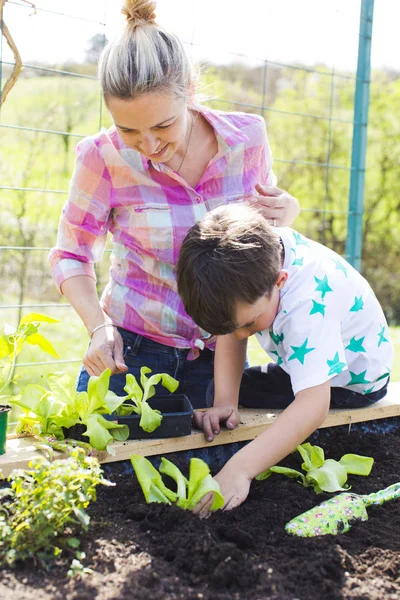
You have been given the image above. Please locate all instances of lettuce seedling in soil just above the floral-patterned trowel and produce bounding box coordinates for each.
[256,442,374,494]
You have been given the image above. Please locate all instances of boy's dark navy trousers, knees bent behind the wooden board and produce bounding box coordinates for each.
[206,363,389,409]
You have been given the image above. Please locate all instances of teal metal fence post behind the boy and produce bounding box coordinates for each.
[346,0,374,270]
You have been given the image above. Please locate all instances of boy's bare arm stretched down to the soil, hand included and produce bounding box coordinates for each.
[195,381,330,513]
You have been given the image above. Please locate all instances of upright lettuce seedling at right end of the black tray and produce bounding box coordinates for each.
[116,367,179,433]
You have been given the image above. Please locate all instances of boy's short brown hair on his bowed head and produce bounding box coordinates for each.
[177,204,282,335]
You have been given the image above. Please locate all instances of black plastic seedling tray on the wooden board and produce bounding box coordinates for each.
[64,394,193,442]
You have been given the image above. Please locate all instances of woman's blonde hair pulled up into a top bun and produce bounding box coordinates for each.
[99,0,193,99]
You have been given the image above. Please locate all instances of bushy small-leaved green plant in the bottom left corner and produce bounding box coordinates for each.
[0,449,114,568]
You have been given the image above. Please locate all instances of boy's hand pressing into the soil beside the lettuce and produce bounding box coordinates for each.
[193,461,251,518]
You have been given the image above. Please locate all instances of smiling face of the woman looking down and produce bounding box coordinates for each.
[107,93,191,163]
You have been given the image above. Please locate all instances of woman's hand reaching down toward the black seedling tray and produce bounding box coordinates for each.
[83,326,128,376]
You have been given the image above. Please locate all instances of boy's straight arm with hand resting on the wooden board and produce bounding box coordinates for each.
[194,334,247,442]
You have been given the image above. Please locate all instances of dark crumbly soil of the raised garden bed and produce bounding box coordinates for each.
[0,420,400,600]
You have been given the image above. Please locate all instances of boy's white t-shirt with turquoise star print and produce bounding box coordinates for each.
[256,227,393,394]
